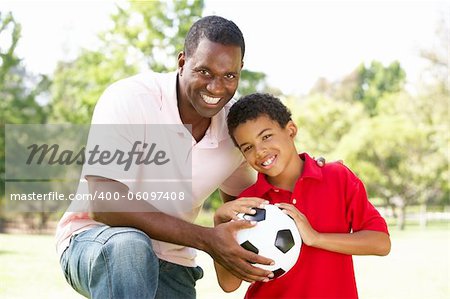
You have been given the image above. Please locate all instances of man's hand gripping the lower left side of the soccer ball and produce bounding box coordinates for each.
[205,220,273,282]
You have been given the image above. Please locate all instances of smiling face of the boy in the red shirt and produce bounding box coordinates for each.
[234,115,298,177]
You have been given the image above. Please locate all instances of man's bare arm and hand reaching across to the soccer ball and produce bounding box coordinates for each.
[86,176,271,282]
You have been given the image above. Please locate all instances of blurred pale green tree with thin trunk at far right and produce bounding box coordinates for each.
[336,92,449,229]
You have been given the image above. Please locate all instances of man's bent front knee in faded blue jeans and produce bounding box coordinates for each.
[89,228,159,298]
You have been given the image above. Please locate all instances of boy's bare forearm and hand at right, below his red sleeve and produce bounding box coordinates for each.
[277,204,391,256]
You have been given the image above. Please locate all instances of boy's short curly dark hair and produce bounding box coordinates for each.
[227,93,292,146]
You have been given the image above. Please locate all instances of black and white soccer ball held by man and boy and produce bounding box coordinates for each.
[236,205,302,278]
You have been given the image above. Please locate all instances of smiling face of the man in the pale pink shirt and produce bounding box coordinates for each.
[178,38,242,118]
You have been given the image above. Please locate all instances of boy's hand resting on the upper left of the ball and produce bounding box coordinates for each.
[214,197,269,226]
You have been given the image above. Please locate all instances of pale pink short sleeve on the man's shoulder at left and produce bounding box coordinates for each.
[82,81,145,190]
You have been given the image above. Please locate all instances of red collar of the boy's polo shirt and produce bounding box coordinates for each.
[254,153,322,197]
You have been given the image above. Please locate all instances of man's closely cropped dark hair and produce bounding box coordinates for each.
[184,16,245,59]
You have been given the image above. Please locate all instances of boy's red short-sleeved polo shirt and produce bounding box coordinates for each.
[240,153,388,299]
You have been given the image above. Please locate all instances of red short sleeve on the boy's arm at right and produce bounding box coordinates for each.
[347,177,389,233]
